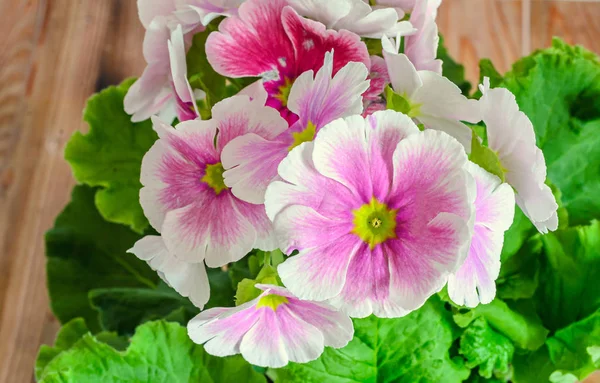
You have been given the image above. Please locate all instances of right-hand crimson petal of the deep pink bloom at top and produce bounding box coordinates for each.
[281,6,370,74]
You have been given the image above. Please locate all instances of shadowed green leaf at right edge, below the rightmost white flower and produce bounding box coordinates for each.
[536,221,600,330]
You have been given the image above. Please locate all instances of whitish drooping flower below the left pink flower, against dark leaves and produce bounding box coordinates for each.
[127,235,210,309]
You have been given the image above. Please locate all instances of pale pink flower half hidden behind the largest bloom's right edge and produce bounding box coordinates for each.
[448,162,515,307]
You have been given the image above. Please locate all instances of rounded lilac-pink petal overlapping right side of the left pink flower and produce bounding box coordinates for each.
[221,133,289,204]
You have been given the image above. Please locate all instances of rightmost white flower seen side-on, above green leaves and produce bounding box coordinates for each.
[479,77,558,234]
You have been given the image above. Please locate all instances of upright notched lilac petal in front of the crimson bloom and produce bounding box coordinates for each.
[288,52,369,128]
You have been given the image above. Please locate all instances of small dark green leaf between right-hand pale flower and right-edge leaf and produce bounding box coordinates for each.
[496,235,542,299]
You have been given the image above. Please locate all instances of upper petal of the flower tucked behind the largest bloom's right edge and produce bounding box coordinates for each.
[467,162,515,232]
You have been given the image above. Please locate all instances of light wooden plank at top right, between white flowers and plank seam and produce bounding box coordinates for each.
[438,0,523,84]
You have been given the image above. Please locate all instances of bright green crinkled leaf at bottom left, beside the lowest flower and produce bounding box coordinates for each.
[35,322,265,383]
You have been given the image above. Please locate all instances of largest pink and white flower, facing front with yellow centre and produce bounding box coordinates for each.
[265,110,475,317]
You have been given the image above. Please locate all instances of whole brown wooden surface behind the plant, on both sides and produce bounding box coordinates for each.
[0,0,600,383]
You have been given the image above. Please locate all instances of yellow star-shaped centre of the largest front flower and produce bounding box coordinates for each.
[352,197,398,249]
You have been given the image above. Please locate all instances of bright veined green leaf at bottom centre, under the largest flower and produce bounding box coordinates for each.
[269,296,469,383]
